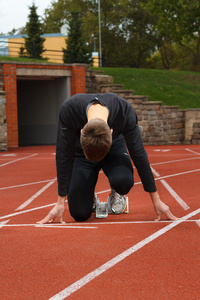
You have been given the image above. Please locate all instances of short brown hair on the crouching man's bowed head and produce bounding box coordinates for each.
[80,118,112,161]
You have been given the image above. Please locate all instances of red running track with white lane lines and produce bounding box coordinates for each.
[0,145,200,300]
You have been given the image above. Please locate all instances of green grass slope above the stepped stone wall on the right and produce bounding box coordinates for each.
[92,68,200,109]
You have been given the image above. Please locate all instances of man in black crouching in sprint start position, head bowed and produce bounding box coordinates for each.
[38,93,177,224]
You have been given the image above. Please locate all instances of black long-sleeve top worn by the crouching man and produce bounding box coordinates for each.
[56,93,156,196]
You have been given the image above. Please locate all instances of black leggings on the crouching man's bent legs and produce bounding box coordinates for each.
[67,143,134,222]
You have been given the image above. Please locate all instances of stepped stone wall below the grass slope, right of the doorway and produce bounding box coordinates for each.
[86,70,200,145]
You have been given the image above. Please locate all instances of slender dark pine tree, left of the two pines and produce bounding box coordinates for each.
[25,3,45,59]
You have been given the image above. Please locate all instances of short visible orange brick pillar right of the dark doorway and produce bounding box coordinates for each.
[71,65,86,95]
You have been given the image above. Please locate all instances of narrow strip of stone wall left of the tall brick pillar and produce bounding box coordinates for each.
[0,65,7,151]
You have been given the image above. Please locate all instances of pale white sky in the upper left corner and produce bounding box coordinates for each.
[0,0,52,35]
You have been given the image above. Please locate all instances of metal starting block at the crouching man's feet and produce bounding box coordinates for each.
[96,197,129,219]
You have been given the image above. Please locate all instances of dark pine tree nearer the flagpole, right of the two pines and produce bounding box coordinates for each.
[63,11,91,64]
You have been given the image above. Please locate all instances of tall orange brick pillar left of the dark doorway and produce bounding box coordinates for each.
[2,64,19,147]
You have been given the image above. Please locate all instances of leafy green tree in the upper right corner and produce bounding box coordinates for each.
[144,0,200,71]
